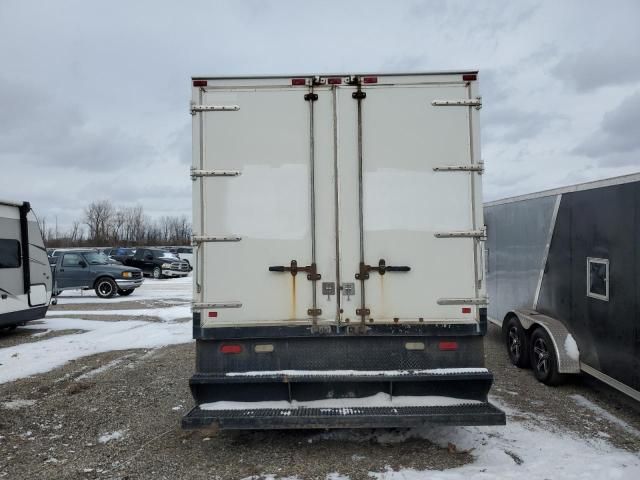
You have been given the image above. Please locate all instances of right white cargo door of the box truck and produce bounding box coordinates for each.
[339,83,479,323]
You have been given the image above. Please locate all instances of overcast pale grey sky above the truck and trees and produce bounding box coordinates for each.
[0,0,640,231]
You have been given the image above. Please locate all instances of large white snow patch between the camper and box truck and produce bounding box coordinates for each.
[0,318,192,383]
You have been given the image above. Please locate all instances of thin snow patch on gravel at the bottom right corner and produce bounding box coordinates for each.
[310,405,640,480]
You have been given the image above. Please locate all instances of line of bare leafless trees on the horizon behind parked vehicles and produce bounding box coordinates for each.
[38,200,191,247]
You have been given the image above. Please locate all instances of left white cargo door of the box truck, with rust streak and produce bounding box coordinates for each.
[194,86,336,327]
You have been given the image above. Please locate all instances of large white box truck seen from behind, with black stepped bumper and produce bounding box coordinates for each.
[183,71,505,429]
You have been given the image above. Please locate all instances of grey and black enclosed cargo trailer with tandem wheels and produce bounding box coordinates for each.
[485,174,640,401]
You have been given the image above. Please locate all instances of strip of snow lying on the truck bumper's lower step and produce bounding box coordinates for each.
[200,392,482,415]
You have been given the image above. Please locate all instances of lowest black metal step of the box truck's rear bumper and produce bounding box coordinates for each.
[182,403,505,430]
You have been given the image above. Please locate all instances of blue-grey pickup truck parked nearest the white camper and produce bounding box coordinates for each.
[52,250,143,298]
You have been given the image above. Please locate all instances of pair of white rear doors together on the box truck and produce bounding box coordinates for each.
[192,75,482,327]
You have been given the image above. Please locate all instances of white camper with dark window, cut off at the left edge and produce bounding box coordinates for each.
[0,200,52,328]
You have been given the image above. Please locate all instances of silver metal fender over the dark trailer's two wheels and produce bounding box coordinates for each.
[507,310,580,373]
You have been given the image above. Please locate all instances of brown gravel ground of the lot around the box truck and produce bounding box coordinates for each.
[0,294,640,479]
